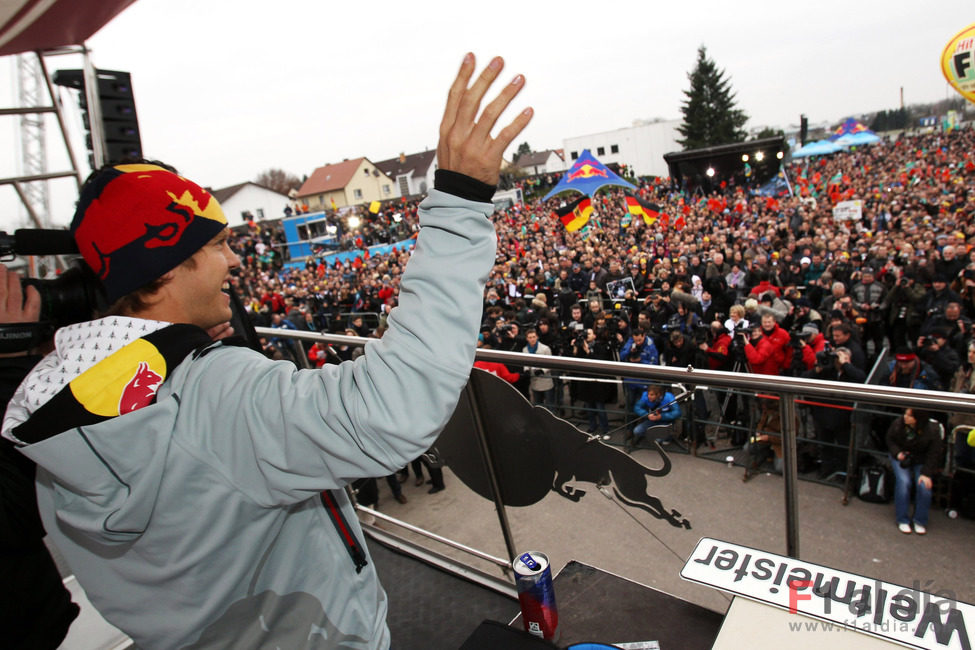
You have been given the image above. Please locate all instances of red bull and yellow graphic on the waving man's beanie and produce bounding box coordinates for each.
[75,164,227,279]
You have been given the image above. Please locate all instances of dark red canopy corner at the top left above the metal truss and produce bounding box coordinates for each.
[0,0,135,56]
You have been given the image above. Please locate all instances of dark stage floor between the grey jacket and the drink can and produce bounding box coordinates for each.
[366,539,520,650]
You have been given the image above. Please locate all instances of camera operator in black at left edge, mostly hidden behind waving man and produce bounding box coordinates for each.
[0,264,79,650]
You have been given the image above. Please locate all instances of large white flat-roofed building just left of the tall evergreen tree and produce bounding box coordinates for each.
[562,120,682,176]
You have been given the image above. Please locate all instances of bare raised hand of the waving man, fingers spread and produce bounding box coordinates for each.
[437,53,533,185]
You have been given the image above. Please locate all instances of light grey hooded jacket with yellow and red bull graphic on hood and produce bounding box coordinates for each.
[3,190,496,649]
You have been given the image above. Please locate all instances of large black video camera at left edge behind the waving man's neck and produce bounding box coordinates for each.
[0,229,108,353]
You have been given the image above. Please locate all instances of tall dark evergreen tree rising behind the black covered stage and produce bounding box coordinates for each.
[677,45,748,150]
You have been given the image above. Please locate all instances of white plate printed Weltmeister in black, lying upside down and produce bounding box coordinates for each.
[680,537,975,650]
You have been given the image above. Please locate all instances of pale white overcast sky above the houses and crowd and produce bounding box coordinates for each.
[0,0,975,229]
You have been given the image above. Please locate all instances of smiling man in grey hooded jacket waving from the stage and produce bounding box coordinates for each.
[3,54,531,648]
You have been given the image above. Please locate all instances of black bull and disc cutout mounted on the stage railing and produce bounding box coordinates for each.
[436,368,691,529]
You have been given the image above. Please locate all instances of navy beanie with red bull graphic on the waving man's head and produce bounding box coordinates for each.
[71,163,227,304]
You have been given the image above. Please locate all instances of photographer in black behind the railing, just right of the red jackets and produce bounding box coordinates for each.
[802,347,867,478]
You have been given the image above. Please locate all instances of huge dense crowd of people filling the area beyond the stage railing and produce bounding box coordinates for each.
[227,128,975,528]
